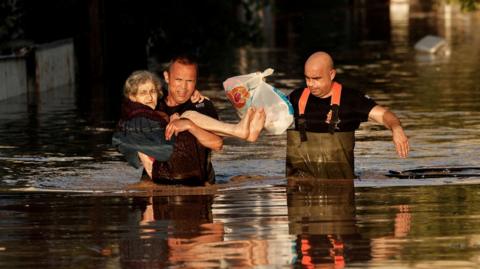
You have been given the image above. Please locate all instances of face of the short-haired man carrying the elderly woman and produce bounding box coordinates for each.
[163,62,197,106]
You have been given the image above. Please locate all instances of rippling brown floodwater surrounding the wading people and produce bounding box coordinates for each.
[0,2,480,268]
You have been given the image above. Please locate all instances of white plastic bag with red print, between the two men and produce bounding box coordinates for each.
[223,68,293,134]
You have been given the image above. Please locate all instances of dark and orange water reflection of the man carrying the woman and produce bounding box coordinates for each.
[120,195,224,268]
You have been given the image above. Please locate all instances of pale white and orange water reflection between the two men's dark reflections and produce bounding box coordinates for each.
[213,185,296,268]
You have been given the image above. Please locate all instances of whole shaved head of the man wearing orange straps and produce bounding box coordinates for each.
[304,51,336,98]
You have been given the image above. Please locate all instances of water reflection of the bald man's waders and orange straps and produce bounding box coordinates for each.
[287,179,370,268]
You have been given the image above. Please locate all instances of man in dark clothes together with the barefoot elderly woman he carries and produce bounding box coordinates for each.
[112,56,265,185]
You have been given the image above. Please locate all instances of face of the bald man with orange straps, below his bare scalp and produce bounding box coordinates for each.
[305,64,335,98]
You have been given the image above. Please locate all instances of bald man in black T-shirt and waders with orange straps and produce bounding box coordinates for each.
[286,51,410,179]
